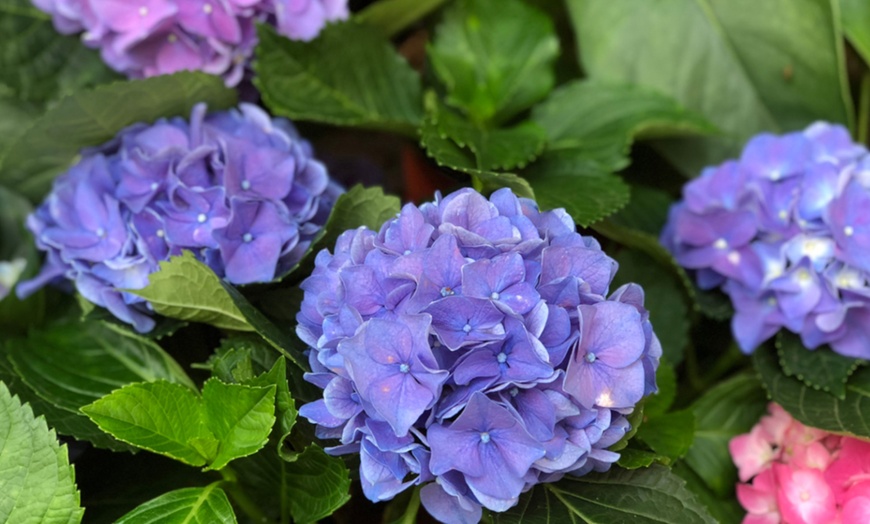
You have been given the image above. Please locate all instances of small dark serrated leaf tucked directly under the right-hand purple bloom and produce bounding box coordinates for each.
[776,331,866,400]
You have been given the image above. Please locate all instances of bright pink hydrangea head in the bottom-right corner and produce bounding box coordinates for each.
[728,403,870,524]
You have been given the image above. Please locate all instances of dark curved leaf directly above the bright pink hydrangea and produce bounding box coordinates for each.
[753,345,870,438]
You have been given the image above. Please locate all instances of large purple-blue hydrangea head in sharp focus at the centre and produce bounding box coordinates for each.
[297,189,661,522]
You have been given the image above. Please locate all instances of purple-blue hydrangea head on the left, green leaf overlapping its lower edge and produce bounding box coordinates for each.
[17,104,341,332]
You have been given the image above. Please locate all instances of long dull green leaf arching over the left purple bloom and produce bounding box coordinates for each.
[0,72,236,200]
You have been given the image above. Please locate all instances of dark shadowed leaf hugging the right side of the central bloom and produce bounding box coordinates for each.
[611,249,690,364]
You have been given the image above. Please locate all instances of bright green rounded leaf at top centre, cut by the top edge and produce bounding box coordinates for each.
[429,0,559,124]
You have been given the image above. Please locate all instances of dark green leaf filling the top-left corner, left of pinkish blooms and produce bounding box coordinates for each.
[0,0,118,103]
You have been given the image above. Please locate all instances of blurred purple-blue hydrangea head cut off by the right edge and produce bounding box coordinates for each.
[661,123,870,358]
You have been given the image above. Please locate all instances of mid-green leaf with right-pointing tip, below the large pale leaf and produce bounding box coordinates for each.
[532,80,716,171]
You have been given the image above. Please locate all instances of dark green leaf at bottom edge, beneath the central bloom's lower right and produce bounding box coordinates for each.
[492,465,716,524]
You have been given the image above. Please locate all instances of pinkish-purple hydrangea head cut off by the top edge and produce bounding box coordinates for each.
[33,0,349,86]
